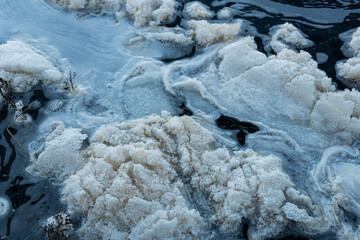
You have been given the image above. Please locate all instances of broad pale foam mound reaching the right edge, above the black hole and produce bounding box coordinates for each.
[169,37,360,142]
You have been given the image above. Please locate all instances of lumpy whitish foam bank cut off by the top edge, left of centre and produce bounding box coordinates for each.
[52,0,175,28]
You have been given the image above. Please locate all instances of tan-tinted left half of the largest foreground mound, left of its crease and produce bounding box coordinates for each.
[63,114,204,239]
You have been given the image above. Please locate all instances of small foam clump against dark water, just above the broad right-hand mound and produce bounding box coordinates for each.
[270,23,314,53]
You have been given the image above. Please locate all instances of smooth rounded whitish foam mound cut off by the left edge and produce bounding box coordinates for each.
[0,41,63,93]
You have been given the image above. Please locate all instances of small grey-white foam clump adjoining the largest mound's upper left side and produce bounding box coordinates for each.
[28,122,87,182]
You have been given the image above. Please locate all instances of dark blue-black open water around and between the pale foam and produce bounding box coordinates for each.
[0,0,360,240]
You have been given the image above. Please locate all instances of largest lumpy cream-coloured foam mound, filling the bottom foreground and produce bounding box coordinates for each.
[62,114,315,239]
